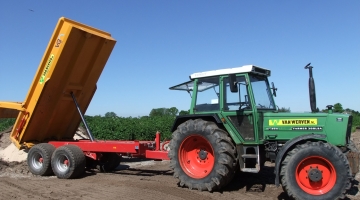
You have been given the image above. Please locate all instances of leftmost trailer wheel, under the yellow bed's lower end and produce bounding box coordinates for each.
[27,143,55,176]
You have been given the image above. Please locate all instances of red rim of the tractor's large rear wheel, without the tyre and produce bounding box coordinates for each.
[179,135,215,179]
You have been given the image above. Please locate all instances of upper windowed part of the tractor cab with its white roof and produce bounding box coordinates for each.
[170,65,276,114]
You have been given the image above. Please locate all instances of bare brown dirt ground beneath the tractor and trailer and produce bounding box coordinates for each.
[0,130,360,200]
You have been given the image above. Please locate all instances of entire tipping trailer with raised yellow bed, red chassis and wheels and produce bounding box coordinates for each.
[0,18,169,178]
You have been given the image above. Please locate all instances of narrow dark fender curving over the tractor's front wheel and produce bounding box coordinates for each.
[274,133,326,187]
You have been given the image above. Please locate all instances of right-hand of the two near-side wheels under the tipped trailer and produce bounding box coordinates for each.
[51,145,86,179]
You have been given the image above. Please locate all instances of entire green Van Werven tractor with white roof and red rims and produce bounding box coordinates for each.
[168,64,359,199]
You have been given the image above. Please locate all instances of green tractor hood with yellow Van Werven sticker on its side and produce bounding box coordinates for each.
[263,113,352,146]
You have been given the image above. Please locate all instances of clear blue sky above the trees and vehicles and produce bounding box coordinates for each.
[0,0,360,117]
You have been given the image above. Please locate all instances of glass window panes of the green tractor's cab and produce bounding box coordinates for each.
[195,74,275,112]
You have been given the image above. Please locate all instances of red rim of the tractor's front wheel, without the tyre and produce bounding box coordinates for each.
[295,156,336,195]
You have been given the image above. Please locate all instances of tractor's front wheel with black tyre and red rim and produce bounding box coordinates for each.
[280,141,352,200]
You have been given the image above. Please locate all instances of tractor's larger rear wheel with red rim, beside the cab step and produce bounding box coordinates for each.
[168,119,236,191]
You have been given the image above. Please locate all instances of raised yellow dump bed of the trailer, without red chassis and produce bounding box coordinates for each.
[0,18,116,148]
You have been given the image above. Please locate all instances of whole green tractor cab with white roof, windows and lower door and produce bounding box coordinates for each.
[170,65,276,144]
